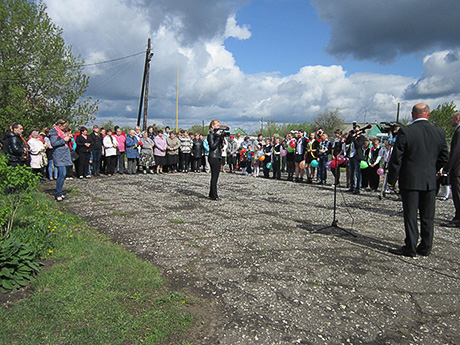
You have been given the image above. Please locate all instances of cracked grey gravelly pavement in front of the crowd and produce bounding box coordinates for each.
[50,174,460,345]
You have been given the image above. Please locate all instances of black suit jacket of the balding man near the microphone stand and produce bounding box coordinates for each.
[388,120,448,191]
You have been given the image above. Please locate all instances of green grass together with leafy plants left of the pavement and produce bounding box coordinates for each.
[0,156,195,344]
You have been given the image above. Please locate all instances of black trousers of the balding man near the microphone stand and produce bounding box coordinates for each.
[401,189,436,255]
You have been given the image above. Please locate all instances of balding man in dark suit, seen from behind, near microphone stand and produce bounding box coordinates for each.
[388,103,448,257]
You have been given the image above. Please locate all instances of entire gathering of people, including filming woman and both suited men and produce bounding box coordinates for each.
[0,103,460,257]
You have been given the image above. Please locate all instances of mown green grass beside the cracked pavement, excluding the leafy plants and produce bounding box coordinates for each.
[0,192,194,344]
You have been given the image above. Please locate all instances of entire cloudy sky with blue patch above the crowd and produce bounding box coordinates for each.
[45,0,460,131]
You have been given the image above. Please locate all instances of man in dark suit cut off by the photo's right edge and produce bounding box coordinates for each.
[443,112,460,228]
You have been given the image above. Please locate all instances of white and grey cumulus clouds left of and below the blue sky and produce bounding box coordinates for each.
[45,0,460,130]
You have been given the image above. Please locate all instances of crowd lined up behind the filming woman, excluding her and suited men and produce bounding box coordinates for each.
[2,119,406,194]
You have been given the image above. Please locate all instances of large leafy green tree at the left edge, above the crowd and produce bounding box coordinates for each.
[0,0,98,132]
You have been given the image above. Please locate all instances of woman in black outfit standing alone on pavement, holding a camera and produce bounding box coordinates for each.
[208,120,224,200]
